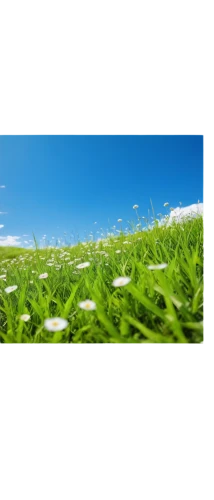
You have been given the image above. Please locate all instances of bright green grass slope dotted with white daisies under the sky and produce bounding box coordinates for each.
[0,216,204,344]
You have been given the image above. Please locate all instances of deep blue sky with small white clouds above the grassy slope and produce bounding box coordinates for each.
[0,129,208,246]
